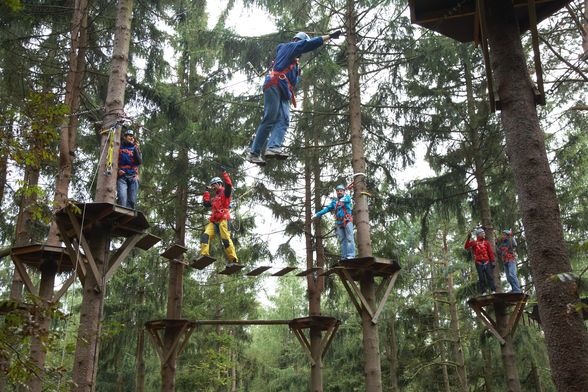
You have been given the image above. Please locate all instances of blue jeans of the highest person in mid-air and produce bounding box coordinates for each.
[251,86,290,156]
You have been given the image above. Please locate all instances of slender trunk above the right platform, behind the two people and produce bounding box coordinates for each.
[464,54,502,293]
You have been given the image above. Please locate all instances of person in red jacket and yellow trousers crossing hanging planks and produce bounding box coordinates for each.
[200,171,238,264]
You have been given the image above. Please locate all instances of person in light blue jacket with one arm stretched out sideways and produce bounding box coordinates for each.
[312,185,355,260]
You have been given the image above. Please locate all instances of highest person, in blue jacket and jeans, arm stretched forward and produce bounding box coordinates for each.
[247,30,341,165]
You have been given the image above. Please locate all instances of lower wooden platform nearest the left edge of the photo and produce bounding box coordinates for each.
[10,244,76,273]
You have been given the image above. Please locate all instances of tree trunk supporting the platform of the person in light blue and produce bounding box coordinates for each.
[345,0,382,392]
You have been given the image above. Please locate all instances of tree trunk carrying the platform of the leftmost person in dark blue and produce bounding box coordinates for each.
[73,0,133,392]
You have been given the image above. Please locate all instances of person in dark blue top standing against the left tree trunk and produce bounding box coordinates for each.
[116,128,143,209]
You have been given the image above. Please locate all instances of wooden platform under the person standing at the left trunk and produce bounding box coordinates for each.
[55,202,149,238]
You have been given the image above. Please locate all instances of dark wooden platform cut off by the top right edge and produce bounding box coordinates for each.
[408,0,570,42]
